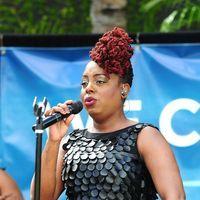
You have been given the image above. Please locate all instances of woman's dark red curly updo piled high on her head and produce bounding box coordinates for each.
[90,27,133,87]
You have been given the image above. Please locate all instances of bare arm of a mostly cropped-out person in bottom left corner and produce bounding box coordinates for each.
[0,169,23,200]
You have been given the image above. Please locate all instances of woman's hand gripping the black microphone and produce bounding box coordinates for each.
[45,100,74,142]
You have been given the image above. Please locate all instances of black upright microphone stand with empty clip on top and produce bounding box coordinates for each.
[33,97,47,200]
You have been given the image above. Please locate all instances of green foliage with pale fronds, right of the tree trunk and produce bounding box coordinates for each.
[128,0,200,32]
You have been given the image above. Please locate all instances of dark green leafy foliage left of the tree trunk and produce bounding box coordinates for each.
[0,0,91,34]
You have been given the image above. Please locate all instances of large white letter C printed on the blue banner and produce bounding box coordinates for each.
[159,98,200,147]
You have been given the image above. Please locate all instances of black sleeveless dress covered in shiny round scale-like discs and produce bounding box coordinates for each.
[62,123,157,200]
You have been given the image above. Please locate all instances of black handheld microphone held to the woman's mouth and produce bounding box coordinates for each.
[32,101,83,131]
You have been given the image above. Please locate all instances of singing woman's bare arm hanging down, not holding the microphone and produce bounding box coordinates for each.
[137,126,185,200]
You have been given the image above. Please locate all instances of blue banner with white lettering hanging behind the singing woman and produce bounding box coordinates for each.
[0,44,200,200]
